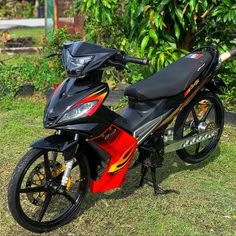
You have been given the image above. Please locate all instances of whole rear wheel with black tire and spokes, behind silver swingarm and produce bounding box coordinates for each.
[174,92,224,164]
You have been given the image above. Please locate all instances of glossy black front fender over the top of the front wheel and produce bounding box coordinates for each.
[30,134,78,152]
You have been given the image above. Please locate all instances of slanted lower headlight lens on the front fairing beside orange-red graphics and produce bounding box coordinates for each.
[58,101,98,123]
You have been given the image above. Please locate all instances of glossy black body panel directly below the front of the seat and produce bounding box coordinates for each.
[116,94,184,132]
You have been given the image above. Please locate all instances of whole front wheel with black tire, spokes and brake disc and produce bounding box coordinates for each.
[8,149,90,233]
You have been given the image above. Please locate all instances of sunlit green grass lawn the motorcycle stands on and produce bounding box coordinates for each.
[0,99,236,236]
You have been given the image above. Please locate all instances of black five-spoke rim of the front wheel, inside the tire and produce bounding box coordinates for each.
[16,151,86,226]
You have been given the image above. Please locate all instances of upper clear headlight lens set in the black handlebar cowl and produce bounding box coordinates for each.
[63,50,93,73]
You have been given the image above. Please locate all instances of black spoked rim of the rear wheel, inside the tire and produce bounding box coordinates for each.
[182,99,220,159]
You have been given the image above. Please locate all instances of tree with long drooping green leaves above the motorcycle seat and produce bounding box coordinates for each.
[77,0,236,69]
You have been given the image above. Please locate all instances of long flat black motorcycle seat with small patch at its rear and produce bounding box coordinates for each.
[125,52,212,101]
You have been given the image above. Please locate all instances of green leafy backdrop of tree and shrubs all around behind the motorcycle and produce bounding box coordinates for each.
[0,0,236,108]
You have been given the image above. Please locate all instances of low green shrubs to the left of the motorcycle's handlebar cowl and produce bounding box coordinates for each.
[0,28,83,97]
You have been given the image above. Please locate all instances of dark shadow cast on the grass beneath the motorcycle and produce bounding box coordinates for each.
[81,146,220,218]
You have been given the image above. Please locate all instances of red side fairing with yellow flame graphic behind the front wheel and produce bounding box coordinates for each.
[89,125,137,193]
